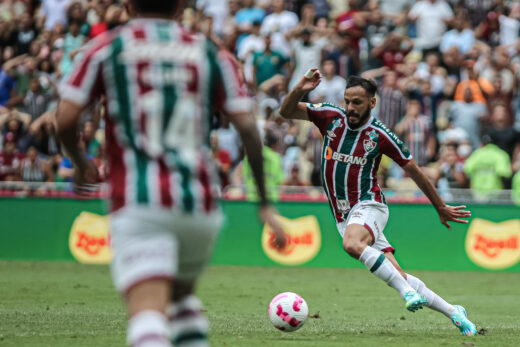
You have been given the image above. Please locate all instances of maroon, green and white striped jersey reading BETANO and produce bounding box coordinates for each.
[307,104,412,222]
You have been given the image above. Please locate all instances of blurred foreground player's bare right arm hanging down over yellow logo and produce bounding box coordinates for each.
[229,113,287,249]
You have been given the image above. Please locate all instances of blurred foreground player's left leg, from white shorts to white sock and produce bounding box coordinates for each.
[111,208,177,347]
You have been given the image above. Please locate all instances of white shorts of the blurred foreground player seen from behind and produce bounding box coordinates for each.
[110,206,222,292]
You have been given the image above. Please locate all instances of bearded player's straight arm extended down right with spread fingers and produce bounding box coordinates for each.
[403,159,471,230]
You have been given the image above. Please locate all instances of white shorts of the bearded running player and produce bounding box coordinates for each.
[337,200,395,253]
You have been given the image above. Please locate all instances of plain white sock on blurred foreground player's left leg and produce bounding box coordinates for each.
[127,310,171,347]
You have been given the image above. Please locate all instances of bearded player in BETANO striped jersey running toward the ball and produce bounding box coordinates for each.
[280,69,477,335]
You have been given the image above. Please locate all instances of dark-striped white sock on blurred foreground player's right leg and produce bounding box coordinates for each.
[166,295,209,347]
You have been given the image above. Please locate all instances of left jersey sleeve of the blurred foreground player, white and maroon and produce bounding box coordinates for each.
[59,33,111,106]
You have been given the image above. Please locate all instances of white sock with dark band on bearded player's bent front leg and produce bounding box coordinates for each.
[359,246,415,299]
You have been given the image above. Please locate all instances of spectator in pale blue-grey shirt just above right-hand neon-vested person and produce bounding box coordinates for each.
[449,88,487,149]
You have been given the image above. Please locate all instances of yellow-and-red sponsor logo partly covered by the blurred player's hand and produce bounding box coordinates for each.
[262,216,321,265]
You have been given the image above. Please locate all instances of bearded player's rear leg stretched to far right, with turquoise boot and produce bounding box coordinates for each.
[385,252,477,335]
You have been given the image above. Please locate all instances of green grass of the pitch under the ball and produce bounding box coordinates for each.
[0,262,520,347]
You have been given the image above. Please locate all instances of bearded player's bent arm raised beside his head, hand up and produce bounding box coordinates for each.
[280,68,321,120]
